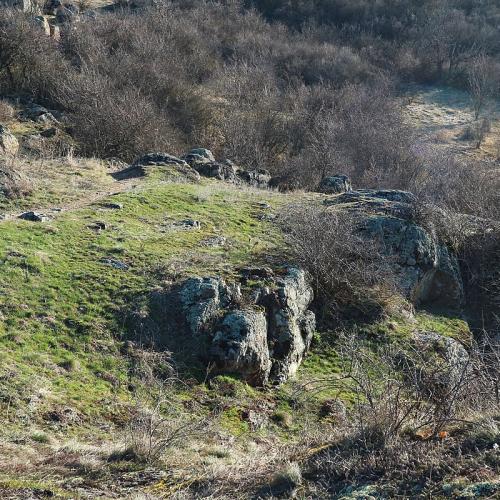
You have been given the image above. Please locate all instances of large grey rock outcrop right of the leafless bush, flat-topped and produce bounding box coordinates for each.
[325,190,464,308]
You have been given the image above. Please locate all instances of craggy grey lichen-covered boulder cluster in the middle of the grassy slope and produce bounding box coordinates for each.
[147,267,316,385]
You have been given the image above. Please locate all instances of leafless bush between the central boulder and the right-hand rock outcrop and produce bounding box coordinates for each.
[281,205,397,320]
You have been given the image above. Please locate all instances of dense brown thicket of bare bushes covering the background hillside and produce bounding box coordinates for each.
[0,0,500,221]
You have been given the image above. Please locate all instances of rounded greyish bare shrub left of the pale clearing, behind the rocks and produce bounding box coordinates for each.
[282,83,420,189]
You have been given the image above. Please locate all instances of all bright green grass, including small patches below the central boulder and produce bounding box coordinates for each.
[0,159,476,454]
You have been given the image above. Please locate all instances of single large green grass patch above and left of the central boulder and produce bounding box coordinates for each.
[0,172,281,428]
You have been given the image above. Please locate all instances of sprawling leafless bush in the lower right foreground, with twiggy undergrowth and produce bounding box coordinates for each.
[304,330,499,494]
